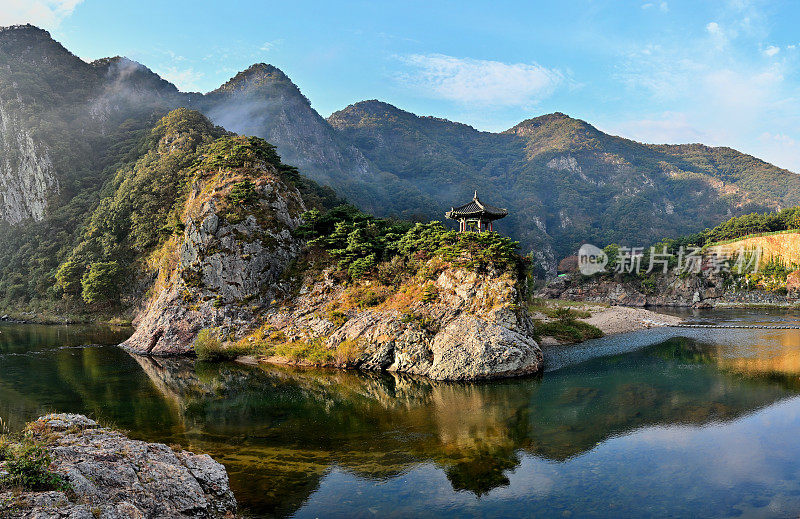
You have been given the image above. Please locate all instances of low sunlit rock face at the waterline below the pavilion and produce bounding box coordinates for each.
[266,268,542,380]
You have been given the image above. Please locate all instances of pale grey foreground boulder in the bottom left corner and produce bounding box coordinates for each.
[0,414,236,519]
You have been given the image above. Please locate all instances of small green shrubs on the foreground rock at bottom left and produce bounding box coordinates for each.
[0,440,68,491]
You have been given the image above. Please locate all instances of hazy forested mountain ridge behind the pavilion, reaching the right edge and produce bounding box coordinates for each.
[328,101,800,272]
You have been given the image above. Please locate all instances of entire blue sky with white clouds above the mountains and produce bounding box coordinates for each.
[0,0,800,172]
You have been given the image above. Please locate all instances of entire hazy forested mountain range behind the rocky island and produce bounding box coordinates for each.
[0,26,800,306]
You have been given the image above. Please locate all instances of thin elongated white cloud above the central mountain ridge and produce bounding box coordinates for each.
[399,54,564,107]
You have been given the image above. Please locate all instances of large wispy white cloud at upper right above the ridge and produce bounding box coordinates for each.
[603,11,800,173]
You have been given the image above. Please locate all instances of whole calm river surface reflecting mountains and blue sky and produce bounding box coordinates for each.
[0,314,800,517]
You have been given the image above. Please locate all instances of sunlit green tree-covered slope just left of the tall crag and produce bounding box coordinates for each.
[55,109,224,302]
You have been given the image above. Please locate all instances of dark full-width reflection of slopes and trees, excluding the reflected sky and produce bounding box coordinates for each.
[0,327,800,516]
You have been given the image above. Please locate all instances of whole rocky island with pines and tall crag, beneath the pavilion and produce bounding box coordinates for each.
[112,116,542,380]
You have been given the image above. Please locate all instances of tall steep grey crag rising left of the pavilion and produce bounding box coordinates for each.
[123,170,305,355]
